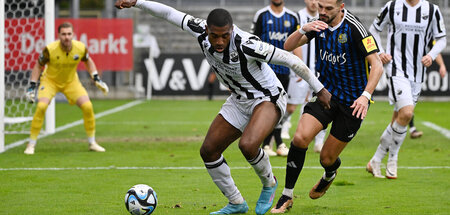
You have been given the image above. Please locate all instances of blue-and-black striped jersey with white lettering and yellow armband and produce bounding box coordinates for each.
[306,9,378,105]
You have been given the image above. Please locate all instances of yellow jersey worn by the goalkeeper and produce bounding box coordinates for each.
[38,40,89,85]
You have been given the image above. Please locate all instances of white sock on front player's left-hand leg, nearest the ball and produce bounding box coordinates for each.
[205,156,244,204]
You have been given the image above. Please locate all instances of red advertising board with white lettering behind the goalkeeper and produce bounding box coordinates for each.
[5,18,133,71]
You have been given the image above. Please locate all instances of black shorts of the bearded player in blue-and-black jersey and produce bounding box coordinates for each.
[303,99,362,142]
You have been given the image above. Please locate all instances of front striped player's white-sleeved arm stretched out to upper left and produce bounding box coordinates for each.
[115,0,187,28]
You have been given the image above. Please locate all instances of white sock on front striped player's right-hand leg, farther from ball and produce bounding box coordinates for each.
[247,148,276,187]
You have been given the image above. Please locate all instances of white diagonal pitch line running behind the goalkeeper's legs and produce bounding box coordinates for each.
[0,100,144,154]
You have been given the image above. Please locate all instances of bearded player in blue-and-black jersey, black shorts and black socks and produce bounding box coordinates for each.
[271,0,383,213]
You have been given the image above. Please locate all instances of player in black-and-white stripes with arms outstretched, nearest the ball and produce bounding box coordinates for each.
[115,0,331,214]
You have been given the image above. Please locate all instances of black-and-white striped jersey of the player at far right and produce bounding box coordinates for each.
[373,0,446,83]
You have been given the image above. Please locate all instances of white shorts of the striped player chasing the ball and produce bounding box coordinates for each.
[219,90,287,132]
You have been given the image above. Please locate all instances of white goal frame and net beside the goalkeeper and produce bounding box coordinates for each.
[0,0,55,153]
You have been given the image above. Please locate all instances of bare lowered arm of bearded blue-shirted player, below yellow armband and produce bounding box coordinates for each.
[350,53,383,119]
